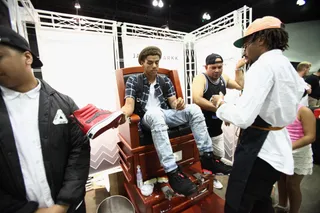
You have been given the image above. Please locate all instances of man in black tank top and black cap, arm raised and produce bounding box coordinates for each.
[192,53,246,189]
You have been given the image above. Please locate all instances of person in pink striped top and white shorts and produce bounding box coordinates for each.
[276,104,316,213]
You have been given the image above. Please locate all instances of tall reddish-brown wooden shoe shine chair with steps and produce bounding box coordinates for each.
[116,66,213,213]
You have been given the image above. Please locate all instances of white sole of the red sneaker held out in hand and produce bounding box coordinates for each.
[87,111,122,139]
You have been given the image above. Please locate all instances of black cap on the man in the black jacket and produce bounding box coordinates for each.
[0,26,43,68]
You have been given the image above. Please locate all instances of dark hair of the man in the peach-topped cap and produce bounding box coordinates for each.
[246,24,289,51]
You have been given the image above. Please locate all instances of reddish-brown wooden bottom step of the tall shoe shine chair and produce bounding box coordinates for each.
[124,162,213,213]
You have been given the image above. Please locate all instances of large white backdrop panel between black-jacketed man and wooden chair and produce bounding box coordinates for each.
[37,28,119,169]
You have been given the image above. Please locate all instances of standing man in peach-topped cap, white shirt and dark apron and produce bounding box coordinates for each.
[212,16,306,213]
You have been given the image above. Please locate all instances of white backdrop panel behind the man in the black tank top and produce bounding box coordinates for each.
[195,25,242,160]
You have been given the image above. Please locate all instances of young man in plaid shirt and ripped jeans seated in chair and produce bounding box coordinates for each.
[120,46,229,196]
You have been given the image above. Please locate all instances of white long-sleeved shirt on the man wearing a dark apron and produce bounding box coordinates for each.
[217,50,305,175]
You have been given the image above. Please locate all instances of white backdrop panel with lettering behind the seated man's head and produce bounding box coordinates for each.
[122,36,185,98]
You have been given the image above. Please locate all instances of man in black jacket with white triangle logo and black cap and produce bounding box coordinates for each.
[0,26,90,213]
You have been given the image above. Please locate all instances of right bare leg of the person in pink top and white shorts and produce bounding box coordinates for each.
[287,174,304,213]
